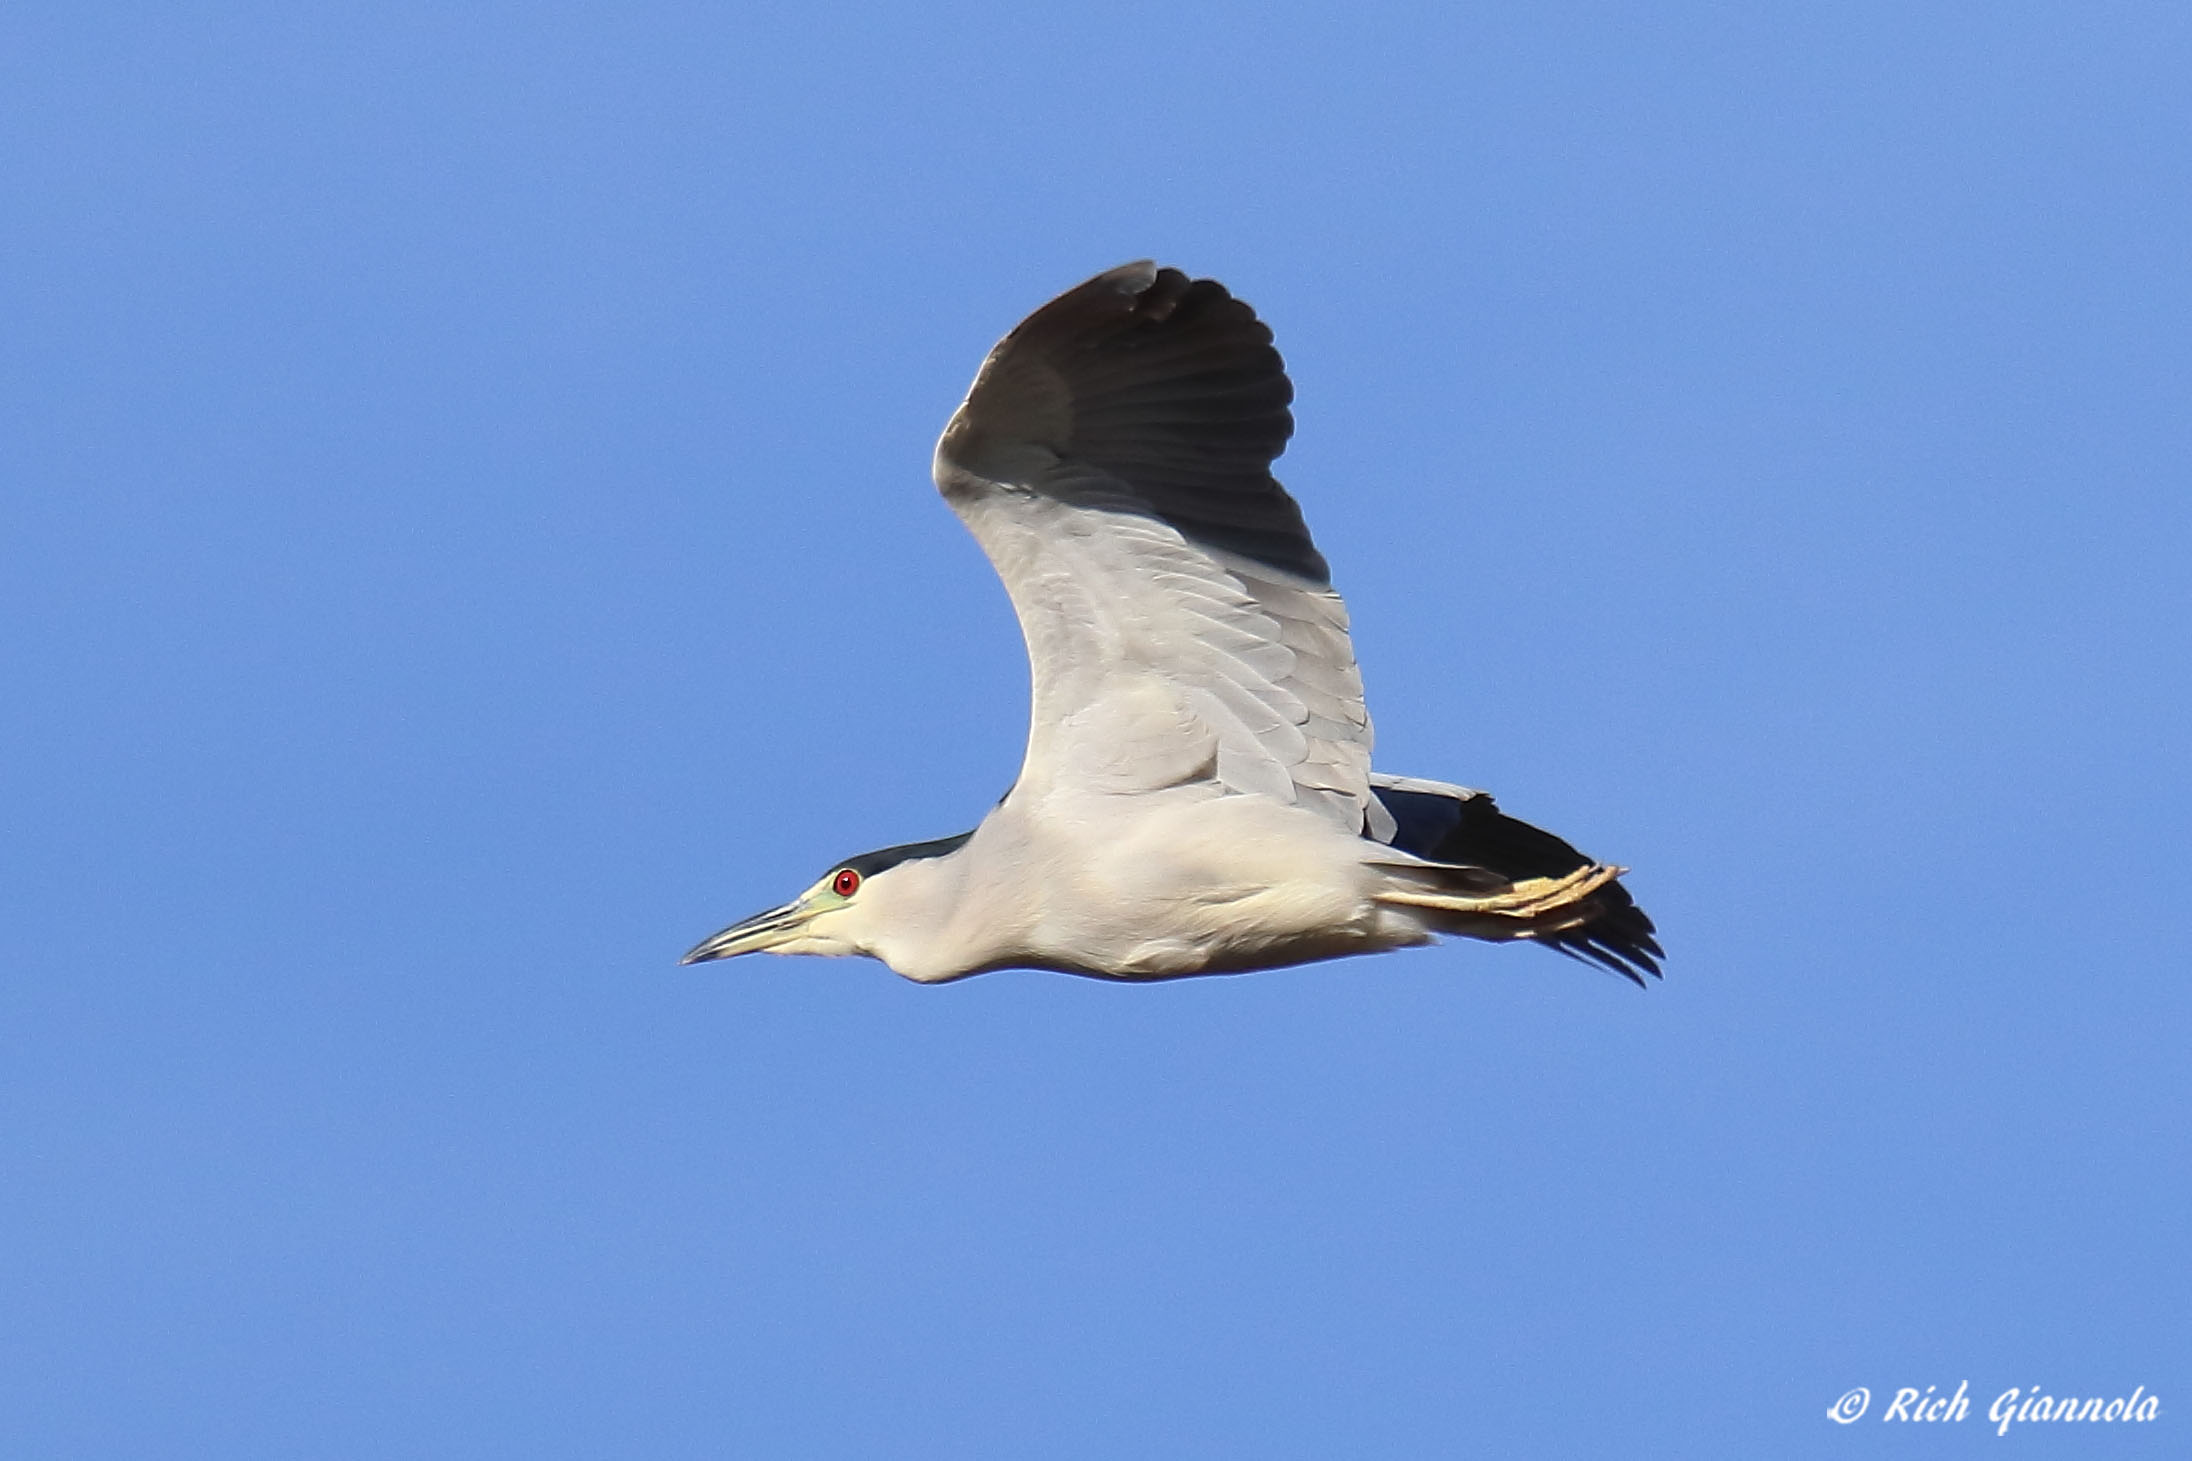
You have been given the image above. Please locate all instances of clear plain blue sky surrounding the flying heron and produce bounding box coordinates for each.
[0,2,2192,1459]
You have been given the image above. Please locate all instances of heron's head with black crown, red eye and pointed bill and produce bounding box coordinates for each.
[682,832,971,968]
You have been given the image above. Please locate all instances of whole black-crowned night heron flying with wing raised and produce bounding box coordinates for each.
[686,263,1659,983]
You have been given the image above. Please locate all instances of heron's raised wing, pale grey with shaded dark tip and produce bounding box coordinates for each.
[936,263,1390,832]
